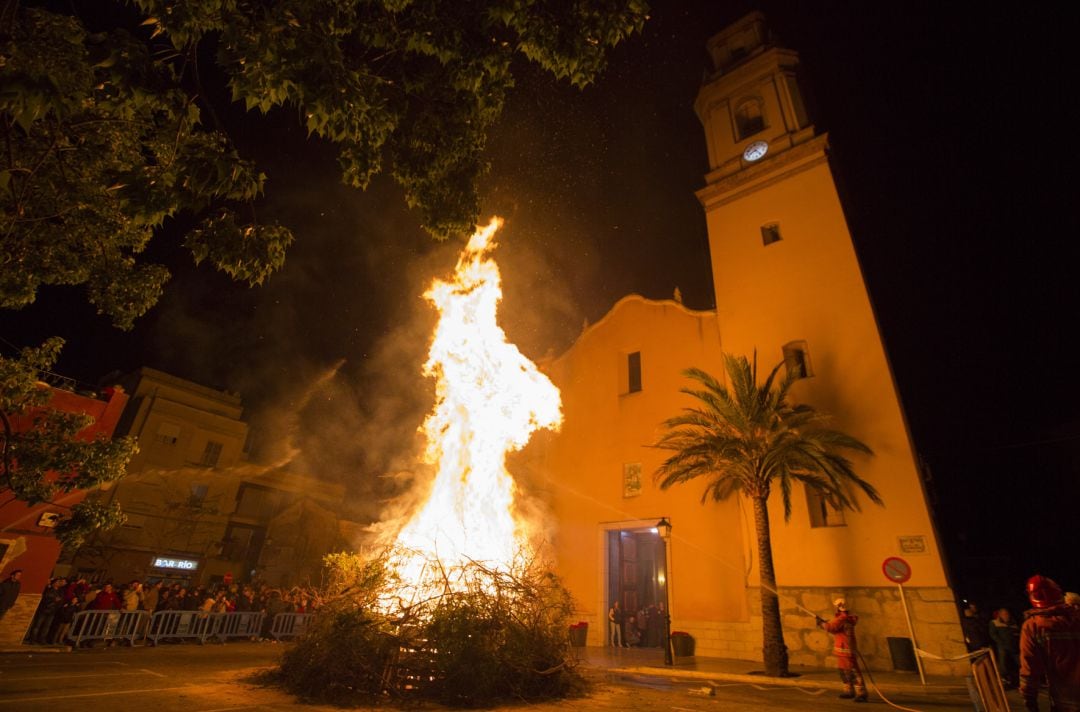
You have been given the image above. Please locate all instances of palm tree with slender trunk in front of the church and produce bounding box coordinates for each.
[653,353,881,677]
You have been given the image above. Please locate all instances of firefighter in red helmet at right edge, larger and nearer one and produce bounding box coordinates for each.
[1020,576,1080,712]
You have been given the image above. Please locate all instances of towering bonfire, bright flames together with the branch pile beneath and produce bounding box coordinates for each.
[281,218,581,707]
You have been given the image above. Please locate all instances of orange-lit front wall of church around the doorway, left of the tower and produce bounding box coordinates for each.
[527,296,747,644]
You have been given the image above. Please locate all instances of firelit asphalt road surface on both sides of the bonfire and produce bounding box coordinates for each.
[0,643,972,712]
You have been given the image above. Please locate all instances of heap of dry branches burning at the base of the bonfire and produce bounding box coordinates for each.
[280,554,583,707]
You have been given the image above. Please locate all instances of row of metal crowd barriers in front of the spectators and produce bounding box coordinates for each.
[67,610,304,646]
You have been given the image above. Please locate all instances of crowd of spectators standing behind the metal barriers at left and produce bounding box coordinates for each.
[26,577,320,645]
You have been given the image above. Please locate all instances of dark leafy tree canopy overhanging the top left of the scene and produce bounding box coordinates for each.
[0,0,647,328]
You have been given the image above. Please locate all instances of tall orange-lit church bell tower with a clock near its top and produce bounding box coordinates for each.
[694,13,956,665]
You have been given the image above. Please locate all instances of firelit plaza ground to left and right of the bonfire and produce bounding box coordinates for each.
[0,642,1023,712]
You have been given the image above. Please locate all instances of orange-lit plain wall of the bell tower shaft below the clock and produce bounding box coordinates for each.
[699,137,947,587]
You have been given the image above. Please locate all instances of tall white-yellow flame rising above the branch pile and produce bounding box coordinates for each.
[393,218,562,586]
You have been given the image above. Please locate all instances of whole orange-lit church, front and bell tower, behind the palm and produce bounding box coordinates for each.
[529,13,966,674]
